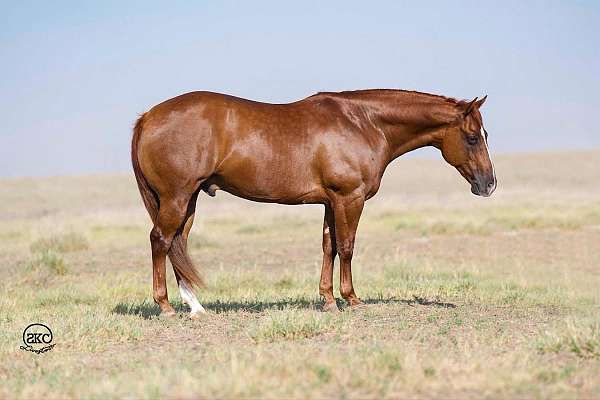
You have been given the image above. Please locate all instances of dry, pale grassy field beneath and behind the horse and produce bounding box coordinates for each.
[0,151,600,398]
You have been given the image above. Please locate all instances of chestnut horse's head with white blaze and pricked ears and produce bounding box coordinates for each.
[441,96,496,197]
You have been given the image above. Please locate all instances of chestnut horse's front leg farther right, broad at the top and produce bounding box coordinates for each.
[331,191,365,307]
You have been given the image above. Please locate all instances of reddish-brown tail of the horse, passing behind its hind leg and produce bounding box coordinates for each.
[131,114,204,287]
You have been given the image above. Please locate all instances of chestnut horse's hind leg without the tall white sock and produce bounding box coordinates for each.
[150,196,189,316]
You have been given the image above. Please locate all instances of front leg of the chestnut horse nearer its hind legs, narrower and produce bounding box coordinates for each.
[319,204,339,311]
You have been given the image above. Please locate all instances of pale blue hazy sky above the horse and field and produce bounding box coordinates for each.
[0,1,600,176]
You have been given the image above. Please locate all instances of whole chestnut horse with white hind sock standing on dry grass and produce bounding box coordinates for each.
[131,89,496,316]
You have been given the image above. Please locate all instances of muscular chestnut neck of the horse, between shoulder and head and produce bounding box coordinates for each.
[346,92,457,161]
